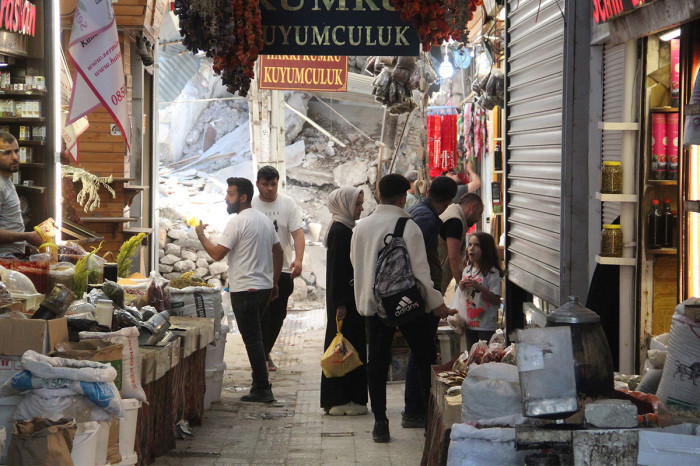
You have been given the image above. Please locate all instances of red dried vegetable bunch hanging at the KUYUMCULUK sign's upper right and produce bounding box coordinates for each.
[392,0,483,52]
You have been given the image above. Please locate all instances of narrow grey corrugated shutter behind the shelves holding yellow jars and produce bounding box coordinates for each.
[602,44,625,224]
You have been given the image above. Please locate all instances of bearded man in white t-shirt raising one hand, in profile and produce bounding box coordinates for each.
[195,178,282,402]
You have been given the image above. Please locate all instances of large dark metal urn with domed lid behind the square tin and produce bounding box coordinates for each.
[547,296,614,397]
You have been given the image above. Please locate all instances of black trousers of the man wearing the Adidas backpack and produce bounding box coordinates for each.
[367,314,437,420]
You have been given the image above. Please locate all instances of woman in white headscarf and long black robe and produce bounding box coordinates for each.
[321,187,367,416]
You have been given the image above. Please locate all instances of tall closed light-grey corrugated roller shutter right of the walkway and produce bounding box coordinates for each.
[507,0,565,303]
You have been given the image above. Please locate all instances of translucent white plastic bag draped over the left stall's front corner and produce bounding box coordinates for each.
[78,327,146,403]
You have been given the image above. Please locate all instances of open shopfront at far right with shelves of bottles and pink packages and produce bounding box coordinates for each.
[589,1,700,372]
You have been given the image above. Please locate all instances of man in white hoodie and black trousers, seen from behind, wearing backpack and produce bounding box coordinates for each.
[350,174,457,443]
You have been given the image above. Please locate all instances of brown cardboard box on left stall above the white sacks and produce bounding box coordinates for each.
[0,318,68,357]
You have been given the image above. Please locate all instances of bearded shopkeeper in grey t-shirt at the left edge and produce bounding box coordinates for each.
[0,131,42,254]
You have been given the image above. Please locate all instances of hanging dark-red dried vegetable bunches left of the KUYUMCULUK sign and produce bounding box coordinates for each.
[175,0,263,96]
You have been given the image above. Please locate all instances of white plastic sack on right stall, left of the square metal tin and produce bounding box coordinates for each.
[462,362,522,422]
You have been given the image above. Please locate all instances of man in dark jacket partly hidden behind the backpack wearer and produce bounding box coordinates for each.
[401,176,457,428]
